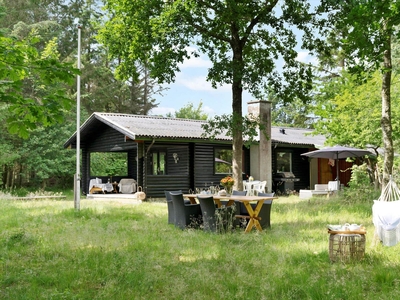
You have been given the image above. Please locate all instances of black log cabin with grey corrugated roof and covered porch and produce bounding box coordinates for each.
[64,109,332,198]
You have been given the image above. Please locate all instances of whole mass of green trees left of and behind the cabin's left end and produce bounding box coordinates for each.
[0,0,161,189]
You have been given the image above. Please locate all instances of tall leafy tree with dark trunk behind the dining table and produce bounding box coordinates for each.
[101,0,316,188]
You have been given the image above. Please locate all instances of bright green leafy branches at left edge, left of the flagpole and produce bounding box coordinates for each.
[0,30,77,138]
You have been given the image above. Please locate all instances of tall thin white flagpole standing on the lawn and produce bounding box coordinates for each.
[74,25,81,210]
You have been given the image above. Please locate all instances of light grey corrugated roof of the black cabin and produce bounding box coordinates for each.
[64,112,325,148]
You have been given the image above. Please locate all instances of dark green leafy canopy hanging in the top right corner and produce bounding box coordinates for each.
[319,1,400,78]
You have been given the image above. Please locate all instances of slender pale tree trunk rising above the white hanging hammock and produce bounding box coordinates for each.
[381,37,394,187]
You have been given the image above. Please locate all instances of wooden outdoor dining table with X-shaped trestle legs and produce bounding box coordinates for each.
[183,194,277,232]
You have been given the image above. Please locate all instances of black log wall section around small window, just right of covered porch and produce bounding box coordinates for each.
[143,142,190,198]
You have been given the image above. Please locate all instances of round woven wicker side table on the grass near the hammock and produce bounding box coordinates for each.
[328,228,367,263]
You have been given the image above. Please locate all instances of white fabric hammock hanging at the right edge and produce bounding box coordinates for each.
[372,177,400,246]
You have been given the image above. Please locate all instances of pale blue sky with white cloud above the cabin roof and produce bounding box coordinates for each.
[150,51,314,117]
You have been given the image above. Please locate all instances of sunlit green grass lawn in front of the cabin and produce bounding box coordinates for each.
[0,193,400,299]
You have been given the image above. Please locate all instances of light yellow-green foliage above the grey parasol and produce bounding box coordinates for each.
[312,72,400,148]
